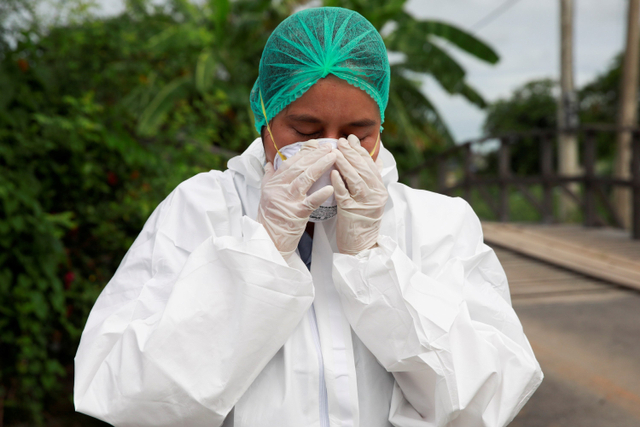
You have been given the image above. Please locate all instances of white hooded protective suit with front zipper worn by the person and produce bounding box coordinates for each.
[74,139,542,427]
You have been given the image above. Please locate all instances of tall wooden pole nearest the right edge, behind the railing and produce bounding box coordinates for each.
[613,0,640,229]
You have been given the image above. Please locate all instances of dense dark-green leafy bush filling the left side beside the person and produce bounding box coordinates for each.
[0,0,225,425]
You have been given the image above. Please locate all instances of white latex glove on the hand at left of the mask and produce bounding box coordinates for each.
[256,140,336,259]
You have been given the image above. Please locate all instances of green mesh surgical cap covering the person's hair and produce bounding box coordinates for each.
[251,7,390,133]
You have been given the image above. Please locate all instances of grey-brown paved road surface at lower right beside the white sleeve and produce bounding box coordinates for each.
[496,250,640,427]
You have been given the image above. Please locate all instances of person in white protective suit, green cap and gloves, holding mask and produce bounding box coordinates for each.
[74,8,542,427]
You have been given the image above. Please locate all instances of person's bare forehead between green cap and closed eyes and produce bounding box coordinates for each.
[283,75,380,123]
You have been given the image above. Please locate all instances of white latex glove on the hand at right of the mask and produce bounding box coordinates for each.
[331,135,389,255]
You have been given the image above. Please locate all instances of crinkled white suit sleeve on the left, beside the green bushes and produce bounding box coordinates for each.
[74,173,313,426]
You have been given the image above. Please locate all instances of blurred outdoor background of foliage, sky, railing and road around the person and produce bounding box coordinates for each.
[0,0,640,427]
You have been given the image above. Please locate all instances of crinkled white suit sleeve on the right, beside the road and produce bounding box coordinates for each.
[333,200,543,427]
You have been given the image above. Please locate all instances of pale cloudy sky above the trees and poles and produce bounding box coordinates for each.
[100,0,627,142]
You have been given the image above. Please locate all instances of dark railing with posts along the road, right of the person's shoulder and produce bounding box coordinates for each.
[402,125,640,239]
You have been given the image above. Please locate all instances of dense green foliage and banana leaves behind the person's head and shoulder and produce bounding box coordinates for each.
[0,0,497,425]
